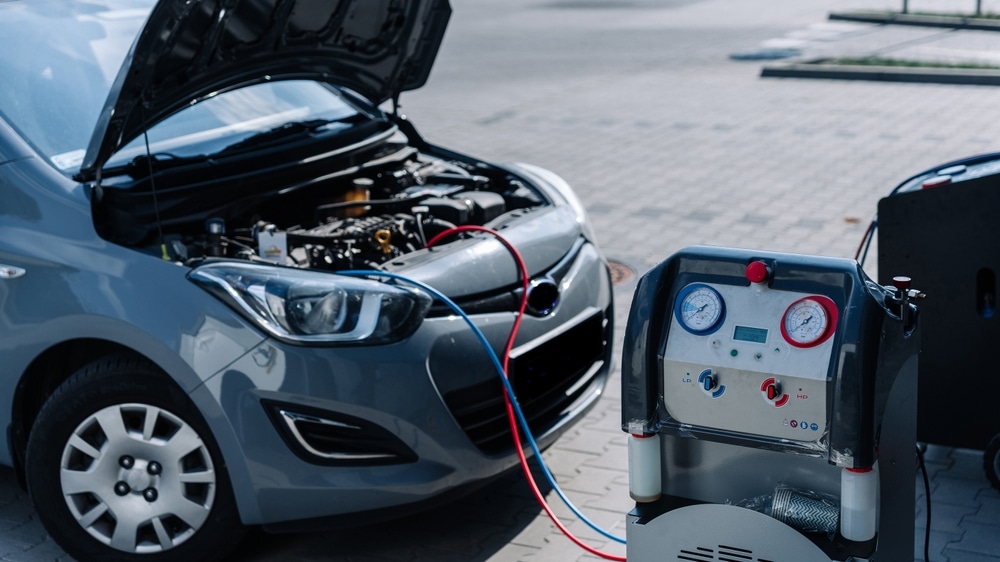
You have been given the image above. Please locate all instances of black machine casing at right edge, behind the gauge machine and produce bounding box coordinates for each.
[878,168,1000,449]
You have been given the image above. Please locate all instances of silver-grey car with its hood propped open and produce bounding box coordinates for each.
[0,0,612,561]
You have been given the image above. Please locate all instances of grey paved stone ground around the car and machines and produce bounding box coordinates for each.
[0,0,1000,562]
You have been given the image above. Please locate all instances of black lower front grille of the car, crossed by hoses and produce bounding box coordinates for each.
[444,306,609,455]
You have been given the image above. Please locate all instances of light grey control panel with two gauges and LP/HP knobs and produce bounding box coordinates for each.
[662,283,839,442]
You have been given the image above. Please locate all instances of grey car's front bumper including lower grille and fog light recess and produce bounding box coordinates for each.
[200,243,613,528]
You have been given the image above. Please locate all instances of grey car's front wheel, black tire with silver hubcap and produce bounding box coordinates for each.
[25,355,244,562]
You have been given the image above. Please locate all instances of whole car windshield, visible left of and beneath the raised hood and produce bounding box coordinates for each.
[0,0,379,174]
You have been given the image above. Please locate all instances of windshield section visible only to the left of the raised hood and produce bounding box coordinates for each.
[0,0,154,170]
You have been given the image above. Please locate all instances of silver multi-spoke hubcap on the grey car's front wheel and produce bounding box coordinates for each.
[60,404,216,554]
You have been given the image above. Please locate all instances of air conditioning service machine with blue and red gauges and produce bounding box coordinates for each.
[622,247,921,562]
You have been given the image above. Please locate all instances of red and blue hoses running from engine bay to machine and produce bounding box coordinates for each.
[338,225,625,562]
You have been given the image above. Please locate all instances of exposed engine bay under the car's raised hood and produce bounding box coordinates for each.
[95,147,547,271]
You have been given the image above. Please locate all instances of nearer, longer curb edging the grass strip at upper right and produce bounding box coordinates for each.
[760,59,1000,86]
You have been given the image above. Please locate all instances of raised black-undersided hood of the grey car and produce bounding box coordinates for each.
[80,0,451,180]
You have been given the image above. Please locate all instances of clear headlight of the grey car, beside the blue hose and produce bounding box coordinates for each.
[188,262,431,345]
